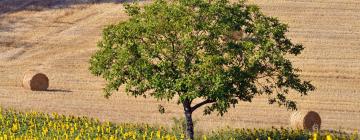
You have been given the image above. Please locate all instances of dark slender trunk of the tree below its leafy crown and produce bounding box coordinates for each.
[183,99,194,140]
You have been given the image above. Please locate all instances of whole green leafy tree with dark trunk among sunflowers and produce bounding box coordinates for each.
[90,0,315,139]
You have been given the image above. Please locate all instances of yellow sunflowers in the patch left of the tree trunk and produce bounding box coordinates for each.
[0,108,173,140]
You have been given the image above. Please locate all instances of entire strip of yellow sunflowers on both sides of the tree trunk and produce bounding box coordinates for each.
[0,108,359,140]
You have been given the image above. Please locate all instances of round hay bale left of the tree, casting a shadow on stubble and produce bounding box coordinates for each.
[22,71,49,91]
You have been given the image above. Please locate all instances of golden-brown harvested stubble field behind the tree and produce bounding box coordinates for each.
[0,0,360,131]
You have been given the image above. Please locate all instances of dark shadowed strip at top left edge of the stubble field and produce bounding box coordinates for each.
[0,0,138,17]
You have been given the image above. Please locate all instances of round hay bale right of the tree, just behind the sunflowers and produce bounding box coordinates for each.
[290,111,321,131]
